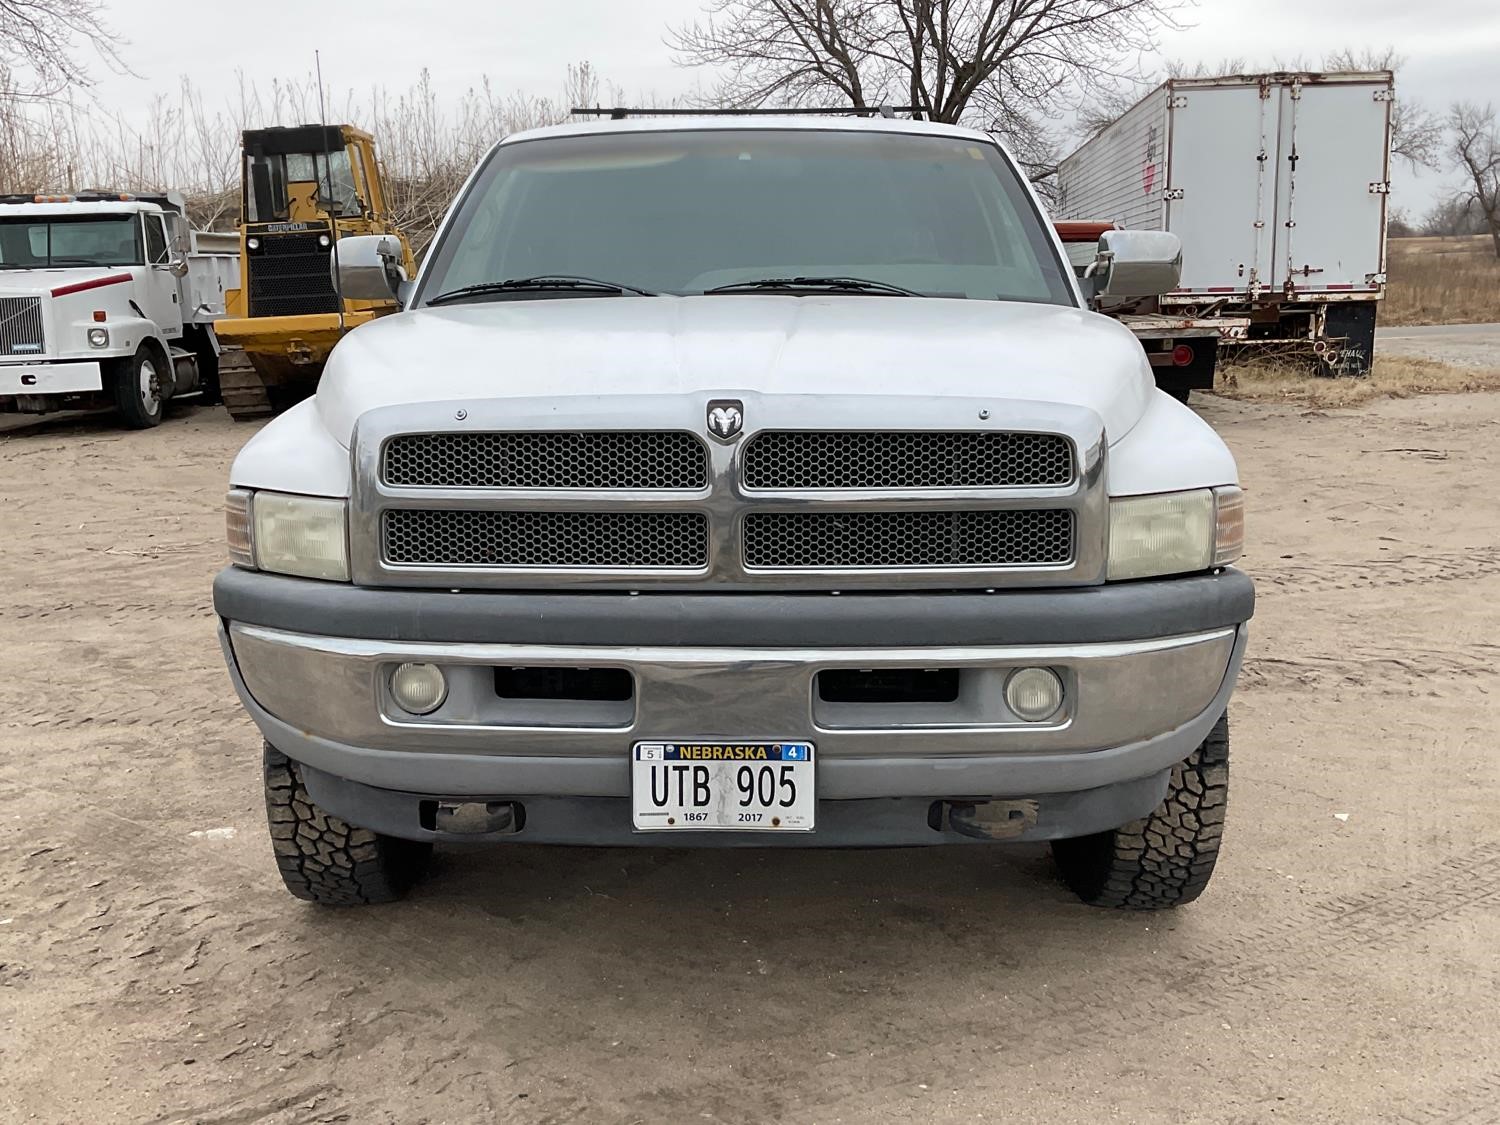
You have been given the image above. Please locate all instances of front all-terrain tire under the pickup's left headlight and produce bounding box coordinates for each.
[264,743,432,906]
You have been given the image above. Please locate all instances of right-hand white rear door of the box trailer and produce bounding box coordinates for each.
[1275,83,1391,294]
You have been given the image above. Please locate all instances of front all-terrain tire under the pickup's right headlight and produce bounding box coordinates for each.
[1052,714,1229,911]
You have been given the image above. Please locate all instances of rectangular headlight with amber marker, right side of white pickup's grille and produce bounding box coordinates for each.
[1109,488,1245,582]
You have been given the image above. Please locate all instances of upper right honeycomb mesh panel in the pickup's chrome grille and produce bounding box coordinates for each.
[744,431,1074,489]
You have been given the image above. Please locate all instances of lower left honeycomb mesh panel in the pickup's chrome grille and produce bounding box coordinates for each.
[384,509,708,570]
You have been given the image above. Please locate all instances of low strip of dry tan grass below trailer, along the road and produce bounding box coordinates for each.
[1214,356,1500,407]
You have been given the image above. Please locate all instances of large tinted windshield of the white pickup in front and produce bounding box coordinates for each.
[423,129,1074,305]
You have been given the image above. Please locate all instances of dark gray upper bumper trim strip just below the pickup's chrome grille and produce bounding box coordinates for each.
[213,567,1256,648]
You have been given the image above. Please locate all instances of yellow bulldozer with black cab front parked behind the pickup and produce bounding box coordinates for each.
[213,125,416,419]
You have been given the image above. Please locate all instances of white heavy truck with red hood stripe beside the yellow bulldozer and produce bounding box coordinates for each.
[0,194,240,428]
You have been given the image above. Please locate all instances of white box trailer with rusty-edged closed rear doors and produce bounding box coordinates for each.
[1058,71,1395,374]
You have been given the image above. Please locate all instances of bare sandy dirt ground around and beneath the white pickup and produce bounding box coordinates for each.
[0,395,1500,1125]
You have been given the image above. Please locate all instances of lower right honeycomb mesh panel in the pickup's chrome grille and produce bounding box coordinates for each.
[744,509,1074,570]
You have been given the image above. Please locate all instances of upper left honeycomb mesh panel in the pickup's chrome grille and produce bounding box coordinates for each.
[383,432,708,491]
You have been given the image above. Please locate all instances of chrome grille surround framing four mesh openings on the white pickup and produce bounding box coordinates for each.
[350,387,1109,591]
